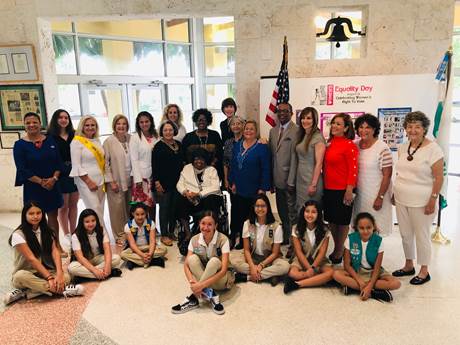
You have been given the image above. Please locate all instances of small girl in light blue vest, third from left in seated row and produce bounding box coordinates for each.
[121,203,167,270]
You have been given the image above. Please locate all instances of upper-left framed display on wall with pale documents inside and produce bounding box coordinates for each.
[0,44,38,83]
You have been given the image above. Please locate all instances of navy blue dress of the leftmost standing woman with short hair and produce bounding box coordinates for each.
[13,136,63,212]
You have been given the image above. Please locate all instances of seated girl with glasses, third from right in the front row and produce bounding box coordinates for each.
[230,194,289,286]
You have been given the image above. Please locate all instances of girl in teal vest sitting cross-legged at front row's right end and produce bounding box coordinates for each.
[334,212,401,302]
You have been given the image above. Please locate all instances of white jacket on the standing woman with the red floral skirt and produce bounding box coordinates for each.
[129,133,158,183]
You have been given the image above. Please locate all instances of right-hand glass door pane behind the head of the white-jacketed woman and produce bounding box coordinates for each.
[127,83,166,132]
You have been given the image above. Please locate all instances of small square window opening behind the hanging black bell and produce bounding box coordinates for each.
[315,10,363,60]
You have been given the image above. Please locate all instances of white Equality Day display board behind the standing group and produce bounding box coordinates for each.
[259,74,438,142]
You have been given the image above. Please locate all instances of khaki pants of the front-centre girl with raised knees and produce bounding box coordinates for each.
[187,254,235,290]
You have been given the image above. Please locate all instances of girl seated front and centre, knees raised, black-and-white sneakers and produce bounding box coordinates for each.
[171,211,235,315]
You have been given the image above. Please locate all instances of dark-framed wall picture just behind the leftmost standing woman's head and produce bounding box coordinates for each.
[0,84,47,131]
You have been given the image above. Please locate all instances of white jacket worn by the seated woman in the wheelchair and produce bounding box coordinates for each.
[176,163,220,197]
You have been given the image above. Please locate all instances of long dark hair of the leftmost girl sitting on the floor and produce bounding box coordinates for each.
[8,201,55,263]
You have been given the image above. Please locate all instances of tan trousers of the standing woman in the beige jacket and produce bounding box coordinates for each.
[106,183,131,242]
